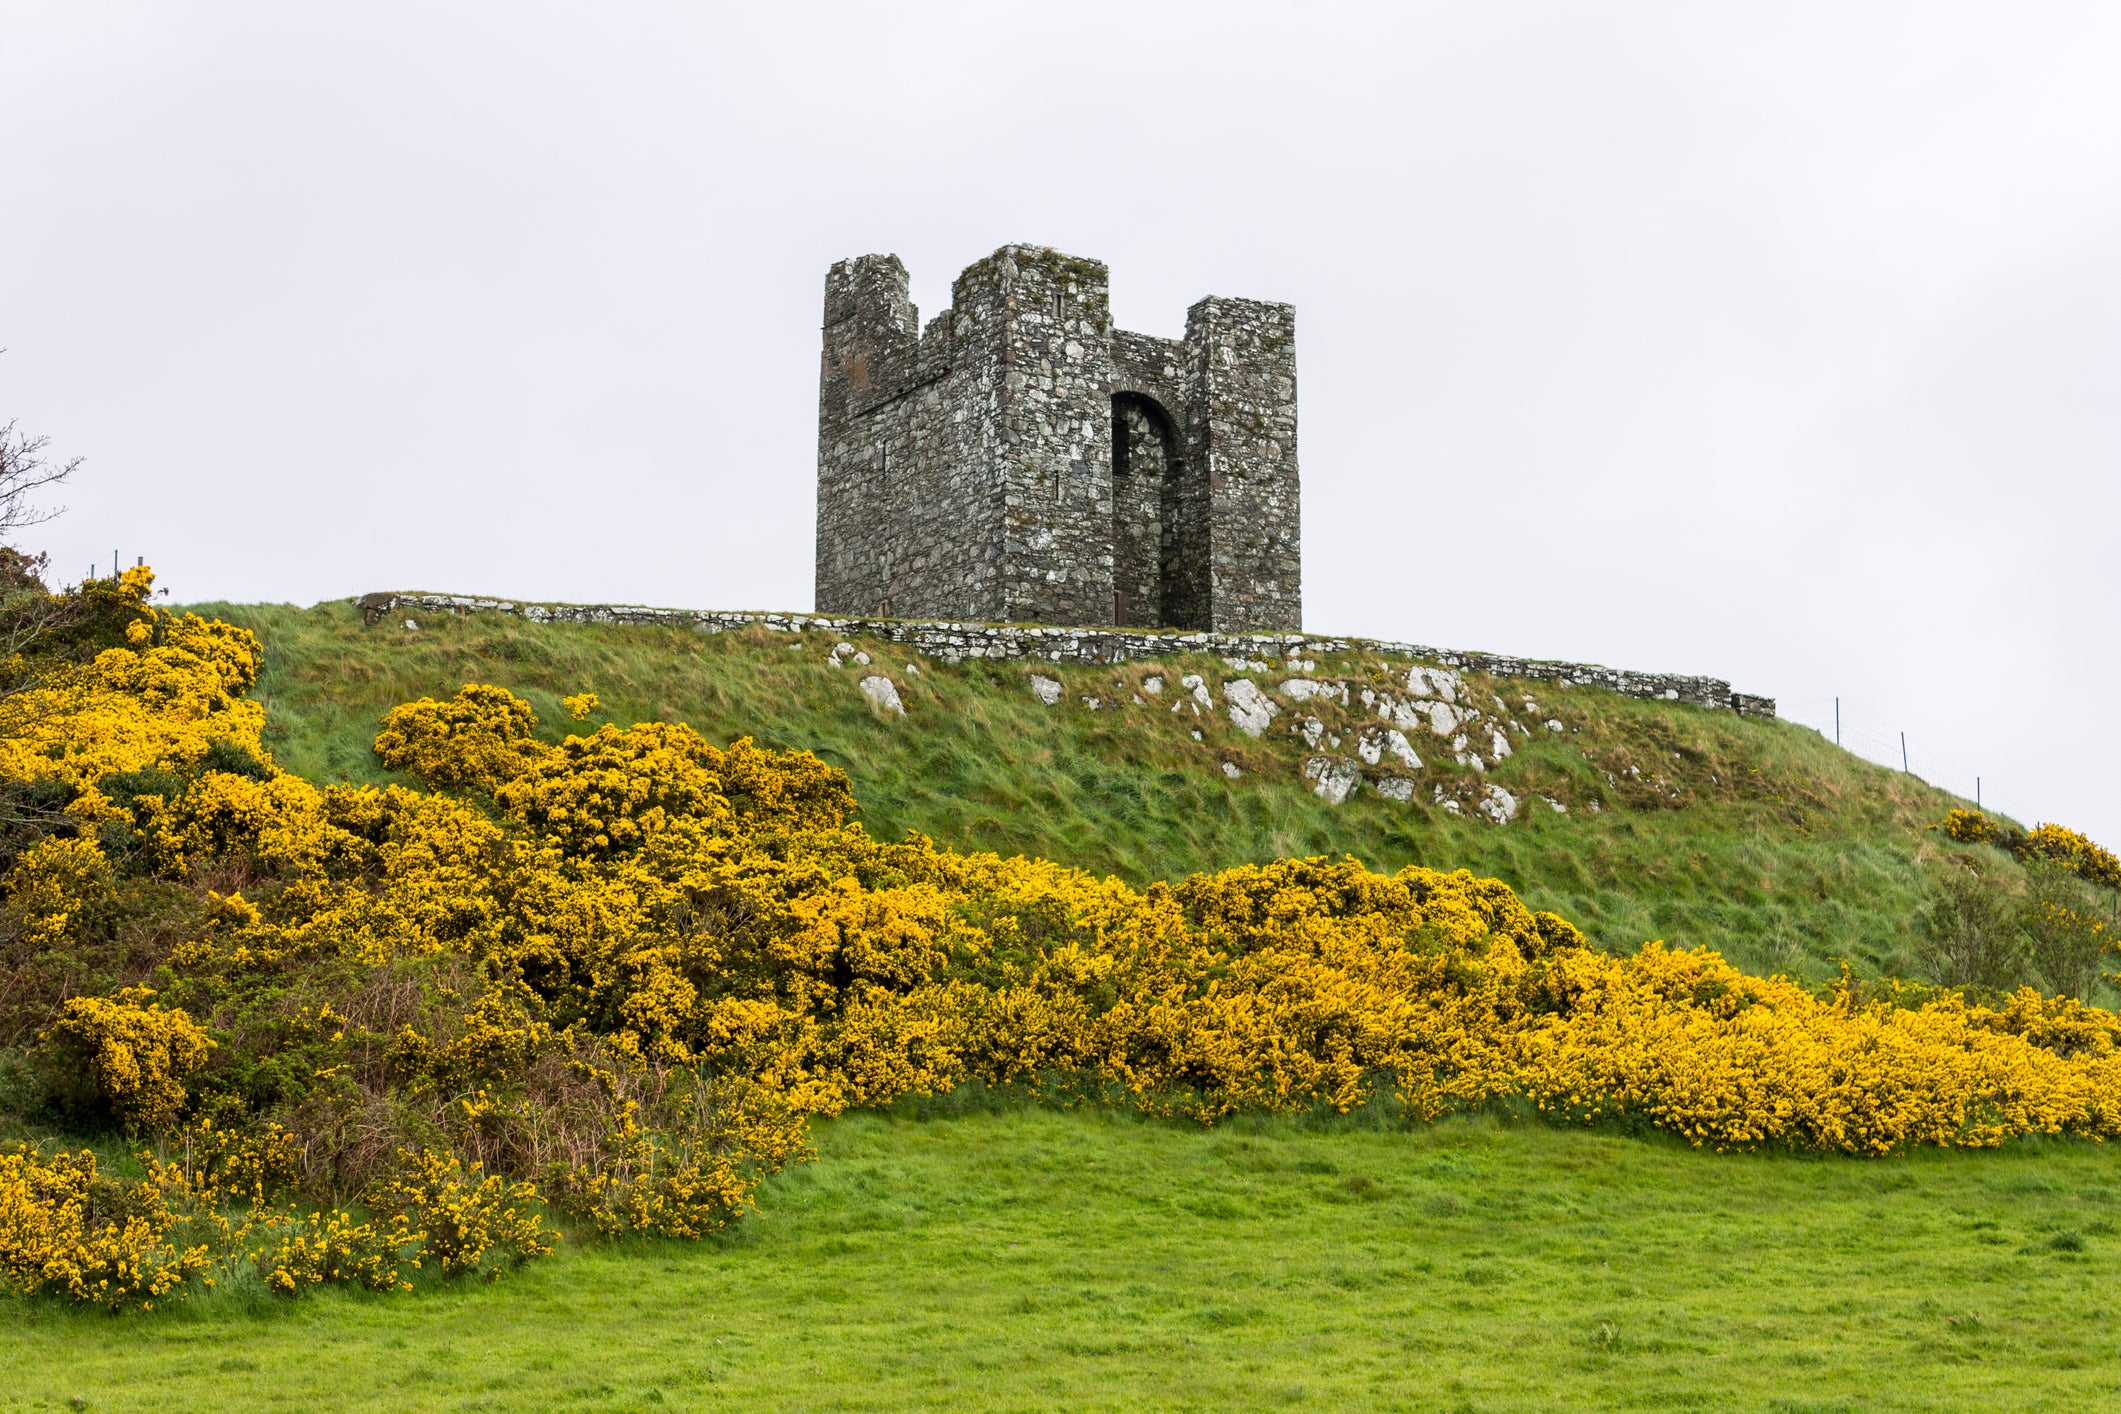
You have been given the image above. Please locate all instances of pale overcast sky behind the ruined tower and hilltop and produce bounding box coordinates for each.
[12,0,2121,846]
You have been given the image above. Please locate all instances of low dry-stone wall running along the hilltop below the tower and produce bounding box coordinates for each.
[354,591,1775,717]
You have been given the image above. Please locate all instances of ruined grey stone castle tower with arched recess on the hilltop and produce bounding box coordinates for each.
[817,246,1302,632]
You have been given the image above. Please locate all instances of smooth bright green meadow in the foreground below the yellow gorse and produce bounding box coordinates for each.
[0,1111,2121,1412]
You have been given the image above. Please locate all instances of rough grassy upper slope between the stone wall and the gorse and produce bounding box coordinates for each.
[204,604,1985,979]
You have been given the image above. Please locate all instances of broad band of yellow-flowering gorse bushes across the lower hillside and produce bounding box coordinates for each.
[0,581,2121,1300]
